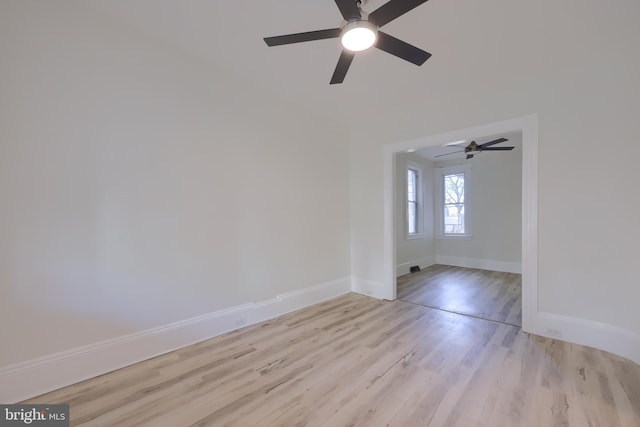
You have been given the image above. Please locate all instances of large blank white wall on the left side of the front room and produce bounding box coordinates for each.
[0,0,350,367]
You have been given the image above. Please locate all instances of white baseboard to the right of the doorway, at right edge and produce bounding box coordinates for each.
[529,312,640,364]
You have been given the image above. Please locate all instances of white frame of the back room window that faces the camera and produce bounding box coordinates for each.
[435,164,473,240]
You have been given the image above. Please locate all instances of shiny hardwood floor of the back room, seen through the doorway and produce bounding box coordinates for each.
[397,265,522,326]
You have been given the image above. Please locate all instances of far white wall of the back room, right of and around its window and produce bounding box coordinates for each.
[436,139,522,272]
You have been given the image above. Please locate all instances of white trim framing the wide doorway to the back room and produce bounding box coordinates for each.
[382,114,538,332]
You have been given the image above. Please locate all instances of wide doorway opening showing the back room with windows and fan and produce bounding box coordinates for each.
[394,132,522,327]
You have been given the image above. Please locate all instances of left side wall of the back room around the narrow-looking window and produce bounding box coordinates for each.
[395,153,435,275]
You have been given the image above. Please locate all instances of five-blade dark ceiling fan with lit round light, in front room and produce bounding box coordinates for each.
[264,0,431,84]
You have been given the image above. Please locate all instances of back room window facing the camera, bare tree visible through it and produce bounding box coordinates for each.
[438,166,470,238]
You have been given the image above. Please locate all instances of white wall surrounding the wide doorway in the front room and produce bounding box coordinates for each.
[350,0,640,354]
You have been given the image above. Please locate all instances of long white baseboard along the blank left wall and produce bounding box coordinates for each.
[0,277,351,404]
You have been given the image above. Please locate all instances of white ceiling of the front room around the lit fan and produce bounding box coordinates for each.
[77,0,564,142]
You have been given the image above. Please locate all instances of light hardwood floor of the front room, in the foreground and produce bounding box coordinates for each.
[25,294,640,427]
